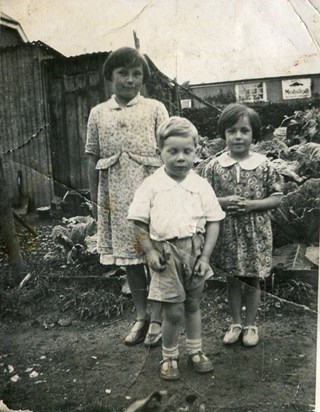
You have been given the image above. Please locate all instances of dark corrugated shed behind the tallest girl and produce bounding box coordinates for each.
[0,42,180,208]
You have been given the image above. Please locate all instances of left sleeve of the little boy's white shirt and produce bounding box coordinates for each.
[127,180,152,224]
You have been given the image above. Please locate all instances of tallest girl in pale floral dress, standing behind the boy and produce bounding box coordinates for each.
[86,47,168,346]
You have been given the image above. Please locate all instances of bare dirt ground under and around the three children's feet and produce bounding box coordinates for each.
[0,214,317,412]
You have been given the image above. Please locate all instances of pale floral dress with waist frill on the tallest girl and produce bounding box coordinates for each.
[85,95,168,266]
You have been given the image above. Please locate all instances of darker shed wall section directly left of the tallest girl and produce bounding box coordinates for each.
[46,53,111,196]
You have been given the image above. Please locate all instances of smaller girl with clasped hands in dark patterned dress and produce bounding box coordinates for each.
[204,103,282,346]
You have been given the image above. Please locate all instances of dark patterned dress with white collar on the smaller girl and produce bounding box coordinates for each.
[204,152,282,278]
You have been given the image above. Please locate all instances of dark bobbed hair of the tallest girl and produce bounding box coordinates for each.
[103,47,151,84]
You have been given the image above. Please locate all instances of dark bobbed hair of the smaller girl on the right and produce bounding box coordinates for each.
[218,103,261,143]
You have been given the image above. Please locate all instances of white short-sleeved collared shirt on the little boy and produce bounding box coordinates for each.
[127,166,225,241]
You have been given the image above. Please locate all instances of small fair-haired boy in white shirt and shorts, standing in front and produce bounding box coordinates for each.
[128,117,225,380]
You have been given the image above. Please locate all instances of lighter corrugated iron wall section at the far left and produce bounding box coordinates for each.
[0,45,53,207]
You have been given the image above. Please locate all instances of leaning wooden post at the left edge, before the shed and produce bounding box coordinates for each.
[0,155,25,283]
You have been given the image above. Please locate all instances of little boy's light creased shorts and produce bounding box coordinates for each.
[148,234,213,303]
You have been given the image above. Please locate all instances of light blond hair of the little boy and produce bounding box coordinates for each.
[157,116,198,149]
